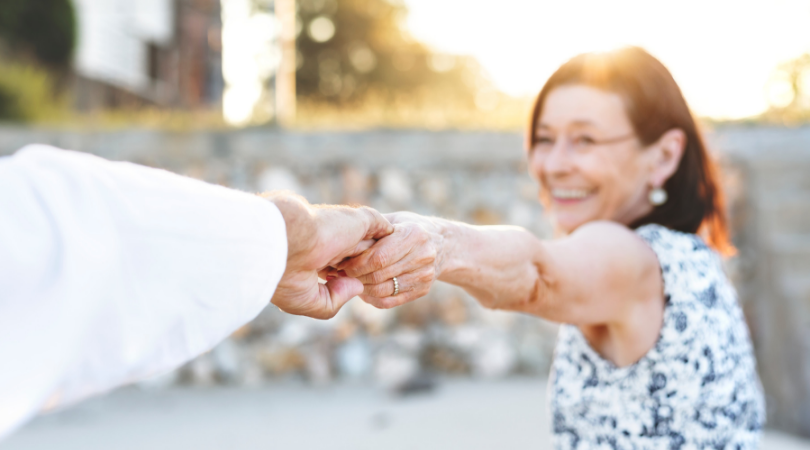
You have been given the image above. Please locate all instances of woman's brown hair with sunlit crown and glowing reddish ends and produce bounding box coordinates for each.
[526,47,734,255]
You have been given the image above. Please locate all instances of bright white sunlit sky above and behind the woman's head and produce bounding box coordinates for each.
[403,0,810,119]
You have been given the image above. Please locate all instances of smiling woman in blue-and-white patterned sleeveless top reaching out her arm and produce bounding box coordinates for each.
[339,48,765,450]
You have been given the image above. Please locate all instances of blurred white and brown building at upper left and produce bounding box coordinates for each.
[74,0,223,110]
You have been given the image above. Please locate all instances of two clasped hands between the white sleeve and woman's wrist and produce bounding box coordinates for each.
[263,193,444,319]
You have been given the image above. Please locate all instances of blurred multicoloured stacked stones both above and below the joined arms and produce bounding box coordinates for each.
[168,153,556,391]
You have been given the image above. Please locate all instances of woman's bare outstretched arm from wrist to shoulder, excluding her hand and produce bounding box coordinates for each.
[439,218,663,325]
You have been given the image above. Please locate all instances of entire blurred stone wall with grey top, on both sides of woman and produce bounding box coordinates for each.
[0,128,810,435]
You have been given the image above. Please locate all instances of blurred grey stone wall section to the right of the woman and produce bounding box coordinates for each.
[713,128,810,436]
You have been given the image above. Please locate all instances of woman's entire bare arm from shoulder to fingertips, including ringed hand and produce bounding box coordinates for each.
[341,213,663,325]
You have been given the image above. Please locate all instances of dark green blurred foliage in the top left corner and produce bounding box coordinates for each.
[0,0,76,68]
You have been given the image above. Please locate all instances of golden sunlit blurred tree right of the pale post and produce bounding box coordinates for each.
[288,0,486,107]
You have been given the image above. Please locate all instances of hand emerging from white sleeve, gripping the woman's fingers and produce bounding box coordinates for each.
[263,192,394,319]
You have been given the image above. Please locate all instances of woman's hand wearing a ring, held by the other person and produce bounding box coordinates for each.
[337,212,444,308]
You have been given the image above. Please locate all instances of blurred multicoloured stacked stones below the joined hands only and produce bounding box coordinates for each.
[162,285,555,391]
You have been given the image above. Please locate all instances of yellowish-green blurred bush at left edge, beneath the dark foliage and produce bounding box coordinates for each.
[0,61,68,122]
